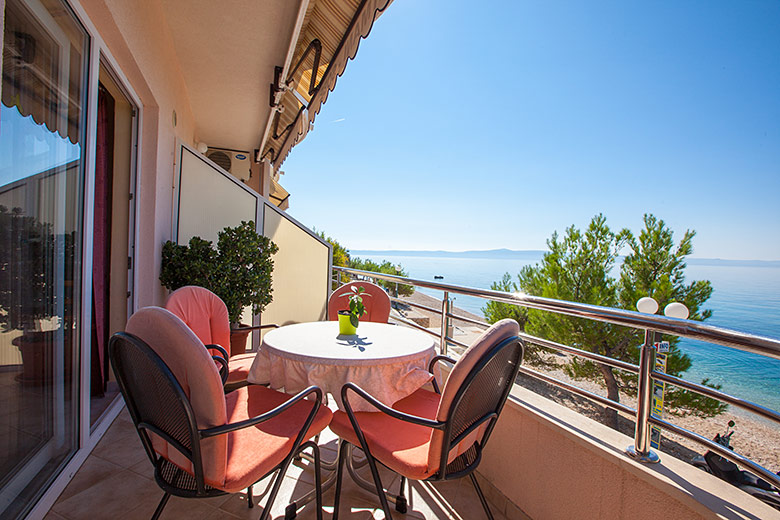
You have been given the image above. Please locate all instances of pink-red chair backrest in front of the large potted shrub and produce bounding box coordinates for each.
[165,285,230,357]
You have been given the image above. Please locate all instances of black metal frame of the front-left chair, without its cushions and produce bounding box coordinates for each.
[109,332,322,520]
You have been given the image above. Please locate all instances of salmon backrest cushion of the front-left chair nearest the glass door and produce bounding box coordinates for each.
[126,307,227,486]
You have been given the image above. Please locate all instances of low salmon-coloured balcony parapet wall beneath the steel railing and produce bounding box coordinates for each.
[479,386,778,520]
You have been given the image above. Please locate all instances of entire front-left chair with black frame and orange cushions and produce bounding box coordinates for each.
[109,307,332,520]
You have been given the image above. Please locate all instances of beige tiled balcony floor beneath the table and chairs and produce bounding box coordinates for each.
[46,404,512,520]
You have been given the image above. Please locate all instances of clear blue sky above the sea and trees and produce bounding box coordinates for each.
[281,0,780,260]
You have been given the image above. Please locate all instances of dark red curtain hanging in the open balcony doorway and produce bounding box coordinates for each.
[91,85,114,396]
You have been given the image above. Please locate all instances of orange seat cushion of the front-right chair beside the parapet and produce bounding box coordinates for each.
[330,388,440,480]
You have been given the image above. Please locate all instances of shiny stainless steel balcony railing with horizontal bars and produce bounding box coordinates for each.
[333,266,780,487]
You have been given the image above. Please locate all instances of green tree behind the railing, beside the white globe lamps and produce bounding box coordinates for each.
[485,215,725,426]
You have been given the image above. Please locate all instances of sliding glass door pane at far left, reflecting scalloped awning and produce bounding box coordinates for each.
[0,0,89,518]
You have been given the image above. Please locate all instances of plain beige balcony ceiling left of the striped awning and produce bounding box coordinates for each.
[162,0,301,152]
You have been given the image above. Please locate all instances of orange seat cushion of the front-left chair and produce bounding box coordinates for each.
[218,385,333,493]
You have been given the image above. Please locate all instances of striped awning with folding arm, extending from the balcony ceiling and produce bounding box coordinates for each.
[262,0,392,168]
